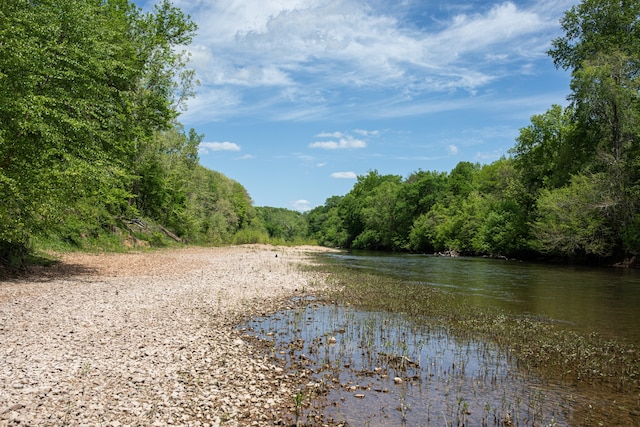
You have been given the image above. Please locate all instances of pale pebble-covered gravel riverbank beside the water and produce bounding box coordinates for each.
[0,245,338,426]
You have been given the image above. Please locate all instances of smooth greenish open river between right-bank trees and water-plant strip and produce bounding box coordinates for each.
[328,252,640,344]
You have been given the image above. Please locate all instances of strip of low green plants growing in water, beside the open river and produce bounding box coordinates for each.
[302,259,640,392]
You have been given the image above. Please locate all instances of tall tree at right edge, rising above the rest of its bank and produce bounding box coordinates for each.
[549,0,640,258]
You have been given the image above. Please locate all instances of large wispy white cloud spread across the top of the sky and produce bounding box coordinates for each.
[176,0,572,122]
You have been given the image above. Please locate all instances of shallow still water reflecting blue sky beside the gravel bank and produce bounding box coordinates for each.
[247,304,579,426]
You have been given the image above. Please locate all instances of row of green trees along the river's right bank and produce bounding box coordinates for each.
[307,0,640,262]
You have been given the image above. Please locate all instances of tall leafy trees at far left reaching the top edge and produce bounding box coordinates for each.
[0,0,195,264]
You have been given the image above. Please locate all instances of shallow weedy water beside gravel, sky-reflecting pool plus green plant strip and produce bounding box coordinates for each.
[241,257,640,426]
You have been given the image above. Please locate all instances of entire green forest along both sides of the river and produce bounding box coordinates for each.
[0,0,640,266]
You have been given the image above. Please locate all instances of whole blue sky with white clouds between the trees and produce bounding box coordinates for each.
[136,0,578,210]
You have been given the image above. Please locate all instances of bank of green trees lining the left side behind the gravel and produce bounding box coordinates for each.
[0,0,268,264]
